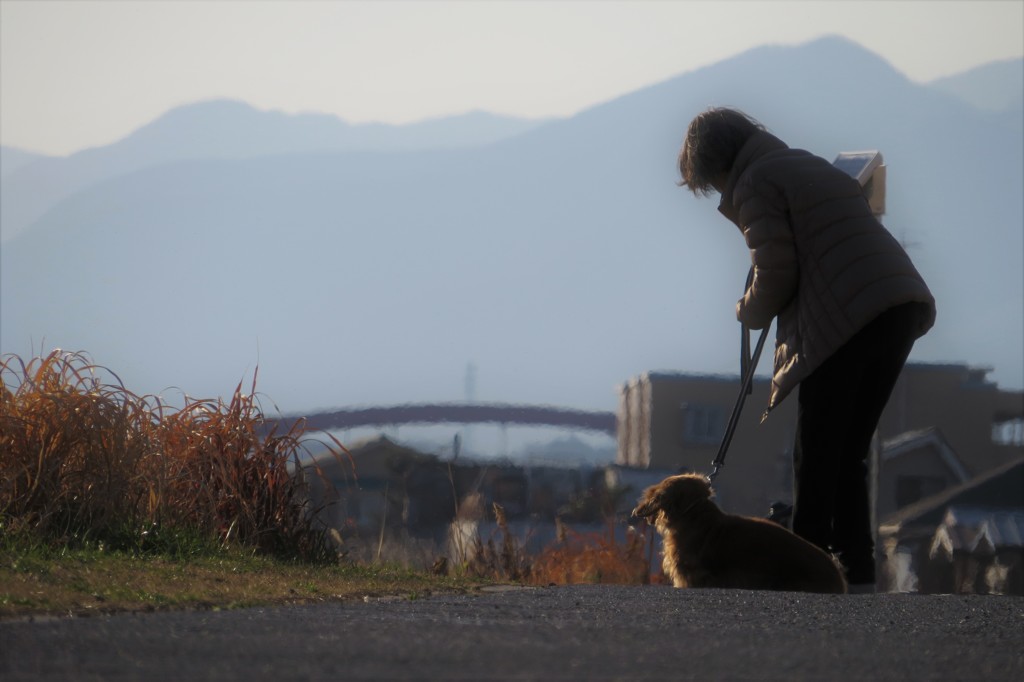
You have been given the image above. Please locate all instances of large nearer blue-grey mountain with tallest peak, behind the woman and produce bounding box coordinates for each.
[0,38,1024,411]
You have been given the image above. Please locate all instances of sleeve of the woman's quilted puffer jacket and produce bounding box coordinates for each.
[736,180,800,329]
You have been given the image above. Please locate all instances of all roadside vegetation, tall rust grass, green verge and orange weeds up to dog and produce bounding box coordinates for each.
[0,350,648,616]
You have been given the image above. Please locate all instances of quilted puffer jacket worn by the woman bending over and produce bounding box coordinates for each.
[719,132,935,410]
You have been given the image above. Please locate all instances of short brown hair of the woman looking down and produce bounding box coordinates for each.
[679,108,765,196]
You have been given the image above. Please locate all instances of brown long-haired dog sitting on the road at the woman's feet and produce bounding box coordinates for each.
[633,474,846,594]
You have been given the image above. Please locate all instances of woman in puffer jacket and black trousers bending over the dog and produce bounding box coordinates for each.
[679,109,935,592]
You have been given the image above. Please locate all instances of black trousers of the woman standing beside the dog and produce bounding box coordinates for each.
[793,303,922,585]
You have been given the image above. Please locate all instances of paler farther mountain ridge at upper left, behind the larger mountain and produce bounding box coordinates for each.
[0,99,544,240]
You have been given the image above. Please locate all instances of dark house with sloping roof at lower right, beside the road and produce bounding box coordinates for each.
[879,457,1024,595]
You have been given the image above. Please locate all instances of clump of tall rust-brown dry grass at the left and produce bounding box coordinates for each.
[0,350,344,560]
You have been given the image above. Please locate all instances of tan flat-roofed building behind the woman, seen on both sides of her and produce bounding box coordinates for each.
[616,363,1024,518]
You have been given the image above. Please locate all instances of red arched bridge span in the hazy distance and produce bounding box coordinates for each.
[271,402,615,436]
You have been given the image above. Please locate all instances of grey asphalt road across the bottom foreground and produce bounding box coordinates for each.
[0,586,1024,682]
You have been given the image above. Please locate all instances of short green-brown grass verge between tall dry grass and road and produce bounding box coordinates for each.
[0,546,488,619]
